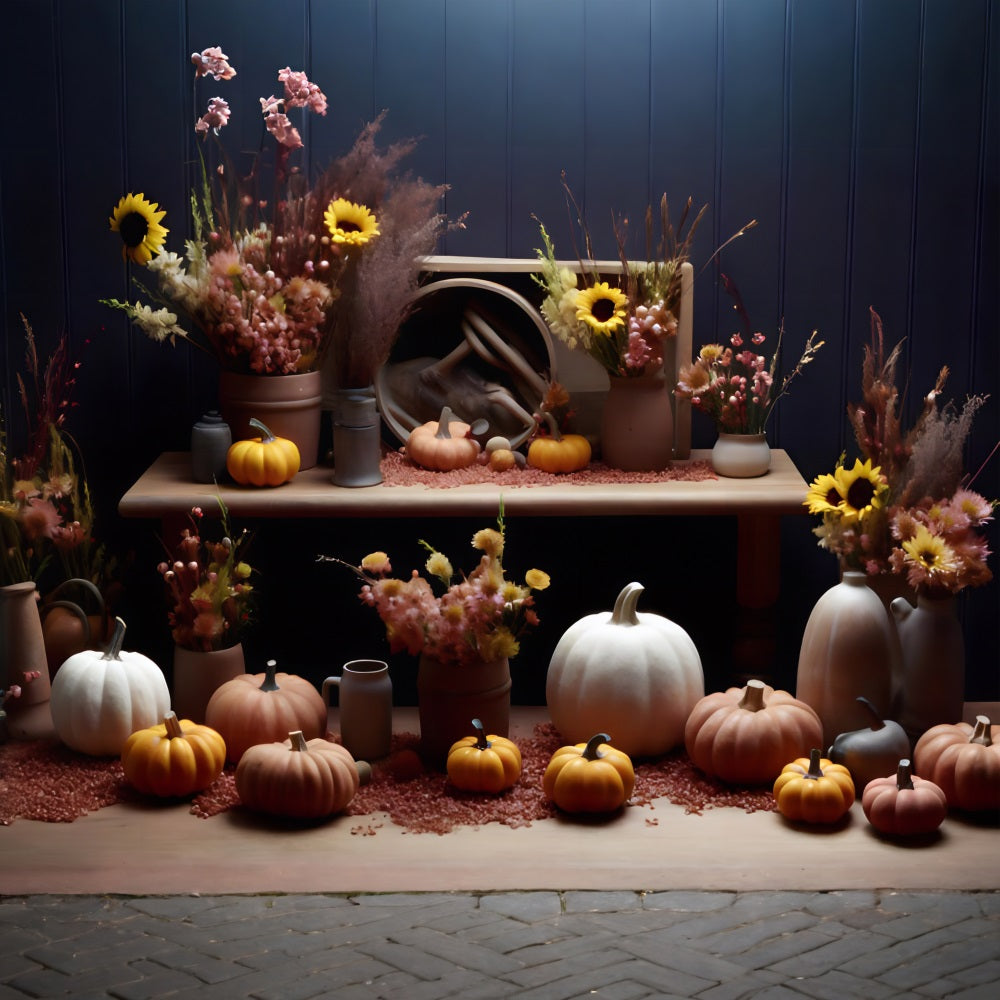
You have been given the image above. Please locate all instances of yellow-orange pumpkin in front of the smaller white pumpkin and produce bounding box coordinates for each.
[122,712,226,797]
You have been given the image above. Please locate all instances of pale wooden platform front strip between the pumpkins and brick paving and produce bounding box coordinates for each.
[0,705,1000,896]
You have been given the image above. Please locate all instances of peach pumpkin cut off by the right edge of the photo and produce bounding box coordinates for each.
[913,715,1000,812]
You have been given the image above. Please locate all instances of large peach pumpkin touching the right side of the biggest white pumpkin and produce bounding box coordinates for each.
[684,680,823,785]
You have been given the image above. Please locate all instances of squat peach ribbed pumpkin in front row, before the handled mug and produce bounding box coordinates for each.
[236,730,360,819]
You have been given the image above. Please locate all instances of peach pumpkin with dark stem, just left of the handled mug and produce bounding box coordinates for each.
[205,660,326,762]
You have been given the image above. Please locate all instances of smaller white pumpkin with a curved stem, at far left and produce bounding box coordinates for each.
[51,618,170,757]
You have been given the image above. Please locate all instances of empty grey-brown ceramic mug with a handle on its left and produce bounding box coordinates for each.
[323,660,392,760]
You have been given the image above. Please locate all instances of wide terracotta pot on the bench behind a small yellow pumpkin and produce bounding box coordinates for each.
[219,371,322,470]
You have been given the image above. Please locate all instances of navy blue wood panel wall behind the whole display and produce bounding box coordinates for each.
[0,0,1000,698]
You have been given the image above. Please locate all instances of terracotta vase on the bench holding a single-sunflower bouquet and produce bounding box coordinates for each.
[601,370,674,472]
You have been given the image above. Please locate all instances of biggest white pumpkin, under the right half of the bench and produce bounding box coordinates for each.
[545,583,705,757]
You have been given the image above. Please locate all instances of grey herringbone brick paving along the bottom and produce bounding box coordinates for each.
[0,891,1000,1000]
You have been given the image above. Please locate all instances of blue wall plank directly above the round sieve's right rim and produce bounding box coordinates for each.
[510,0,586,257]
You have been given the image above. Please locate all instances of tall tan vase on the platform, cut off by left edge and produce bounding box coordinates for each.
[0,581,55,740]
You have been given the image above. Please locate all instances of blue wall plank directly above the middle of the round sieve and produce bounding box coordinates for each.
[443,0,511,257]
